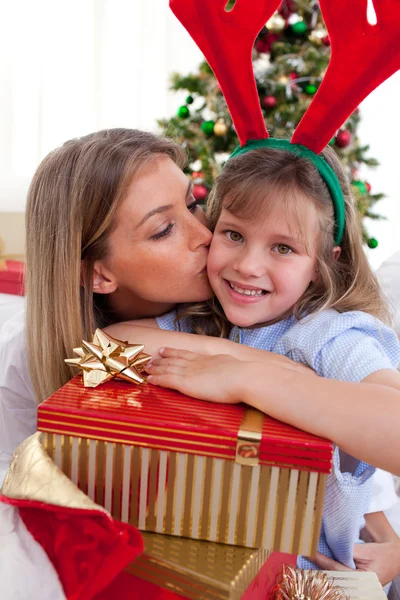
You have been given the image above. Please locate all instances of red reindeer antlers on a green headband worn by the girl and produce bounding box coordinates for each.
[170,0,400,245]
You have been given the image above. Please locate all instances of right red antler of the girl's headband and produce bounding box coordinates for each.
[292,0,400,153]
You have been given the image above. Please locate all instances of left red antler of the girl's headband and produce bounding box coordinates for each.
[170,0,280,145]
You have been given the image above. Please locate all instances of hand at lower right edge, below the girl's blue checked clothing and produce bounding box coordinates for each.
[310,541,400,586]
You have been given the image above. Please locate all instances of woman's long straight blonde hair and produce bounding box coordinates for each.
[26,129,186,402]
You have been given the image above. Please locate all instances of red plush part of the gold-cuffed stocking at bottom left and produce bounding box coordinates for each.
[0,496,143,600]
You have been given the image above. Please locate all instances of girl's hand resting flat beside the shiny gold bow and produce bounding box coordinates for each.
[146,348,251,404]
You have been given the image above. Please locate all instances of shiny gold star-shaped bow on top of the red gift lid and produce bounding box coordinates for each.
[65,329,151,387]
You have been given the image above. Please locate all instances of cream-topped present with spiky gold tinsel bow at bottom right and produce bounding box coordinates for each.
[269,564,386,600]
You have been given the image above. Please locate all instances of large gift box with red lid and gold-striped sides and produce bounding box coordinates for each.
[38,376,332,556]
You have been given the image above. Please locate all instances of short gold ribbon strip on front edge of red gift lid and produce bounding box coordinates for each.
[235,407,264,467]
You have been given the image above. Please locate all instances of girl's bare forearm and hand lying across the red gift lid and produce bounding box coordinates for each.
[148,348,400,475]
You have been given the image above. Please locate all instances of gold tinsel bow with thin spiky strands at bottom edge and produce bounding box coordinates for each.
[271,565,349,600]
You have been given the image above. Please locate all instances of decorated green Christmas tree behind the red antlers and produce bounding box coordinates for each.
[159,0,383,248]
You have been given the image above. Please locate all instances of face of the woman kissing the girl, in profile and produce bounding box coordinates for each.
[94,156,212,318]
